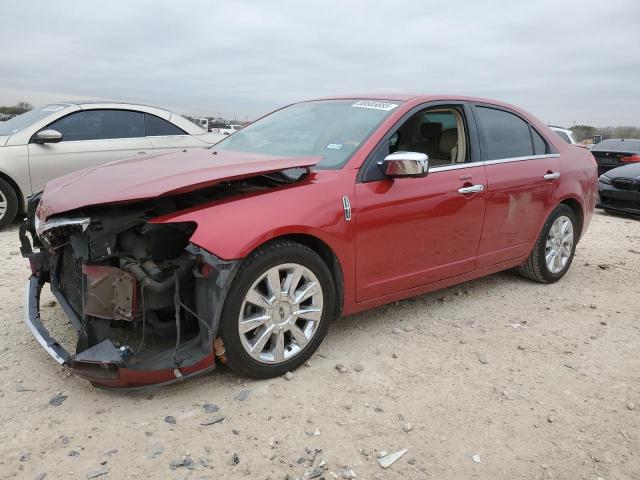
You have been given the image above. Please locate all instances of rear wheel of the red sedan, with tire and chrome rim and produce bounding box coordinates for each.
[519,204,579,283]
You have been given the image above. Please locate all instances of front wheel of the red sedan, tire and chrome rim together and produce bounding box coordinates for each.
[220,240,336,378]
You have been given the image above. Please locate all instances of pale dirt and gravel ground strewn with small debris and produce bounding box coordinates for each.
[0,213,640,480]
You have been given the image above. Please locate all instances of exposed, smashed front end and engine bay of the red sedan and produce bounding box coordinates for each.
[20,168,308,388]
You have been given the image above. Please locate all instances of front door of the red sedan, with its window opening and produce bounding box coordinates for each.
[354,105,487,302]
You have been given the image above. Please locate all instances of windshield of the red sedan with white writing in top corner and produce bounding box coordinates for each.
[215,100,401,169]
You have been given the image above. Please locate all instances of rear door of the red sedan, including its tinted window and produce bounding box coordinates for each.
[474,105,560,269]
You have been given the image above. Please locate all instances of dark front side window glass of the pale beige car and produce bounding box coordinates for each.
[47,110,144,142]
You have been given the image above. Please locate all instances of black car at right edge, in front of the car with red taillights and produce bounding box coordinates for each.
[596,163,640,217]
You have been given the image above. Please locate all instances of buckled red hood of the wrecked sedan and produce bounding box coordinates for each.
[38,149,320,220]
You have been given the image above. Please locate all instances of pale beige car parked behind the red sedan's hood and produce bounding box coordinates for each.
[0,102,224,228]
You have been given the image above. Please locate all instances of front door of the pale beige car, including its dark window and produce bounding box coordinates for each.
[29,109,153,191]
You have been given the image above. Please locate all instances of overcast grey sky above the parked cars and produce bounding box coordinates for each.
[0,0,640,126]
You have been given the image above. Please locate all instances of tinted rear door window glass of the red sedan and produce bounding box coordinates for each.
[476,107,534,160]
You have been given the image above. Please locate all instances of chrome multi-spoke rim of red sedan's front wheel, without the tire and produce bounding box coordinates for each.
[238,263,323,364]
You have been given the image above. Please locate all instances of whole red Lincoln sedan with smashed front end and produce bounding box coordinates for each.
[20,96,597,388]
